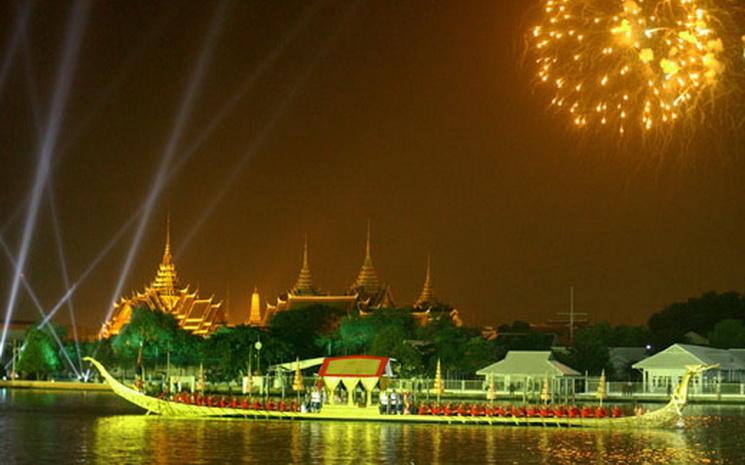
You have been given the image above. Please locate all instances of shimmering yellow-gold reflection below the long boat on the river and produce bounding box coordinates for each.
[91,415,717,465]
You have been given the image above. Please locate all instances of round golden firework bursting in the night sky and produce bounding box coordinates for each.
[529,0,737,135]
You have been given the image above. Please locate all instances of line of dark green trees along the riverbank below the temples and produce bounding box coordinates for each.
[10,292,745,380]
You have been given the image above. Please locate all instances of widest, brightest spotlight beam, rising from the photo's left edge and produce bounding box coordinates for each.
[0,0,90,358]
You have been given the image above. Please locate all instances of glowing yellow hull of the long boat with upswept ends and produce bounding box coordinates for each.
[84,357,714,429]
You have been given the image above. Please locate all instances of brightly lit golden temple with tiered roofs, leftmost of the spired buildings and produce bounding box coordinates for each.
[100,226,226,338]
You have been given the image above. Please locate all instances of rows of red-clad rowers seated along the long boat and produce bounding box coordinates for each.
[161,392,628,418]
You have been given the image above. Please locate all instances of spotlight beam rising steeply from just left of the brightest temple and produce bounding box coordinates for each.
[99,0,228,334]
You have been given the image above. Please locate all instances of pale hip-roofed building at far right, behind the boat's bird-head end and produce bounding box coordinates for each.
[632,344,745,393]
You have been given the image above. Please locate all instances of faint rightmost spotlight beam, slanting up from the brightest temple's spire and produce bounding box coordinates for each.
[176,2,360,256]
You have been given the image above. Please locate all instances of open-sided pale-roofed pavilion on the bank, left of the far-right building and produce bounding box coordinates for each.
[476,350,580,397]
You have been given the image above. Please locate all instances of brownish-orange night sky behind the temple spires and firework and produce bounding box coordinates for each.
[0,0,745,332]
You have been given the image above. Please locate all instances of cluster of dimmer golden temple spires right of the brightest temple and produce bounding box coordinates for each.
[256,225,462,326]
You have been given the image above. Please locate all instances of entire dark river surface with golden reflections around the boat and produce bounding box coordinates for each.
[0,389,745,465]
